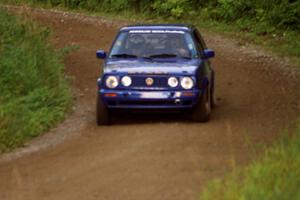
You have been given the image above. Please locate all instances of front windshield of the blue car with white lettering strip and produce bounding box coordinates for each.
[109,30,198,59]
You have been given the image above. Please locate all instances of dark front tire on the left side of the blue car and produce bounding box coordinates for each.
[96,92,111,126]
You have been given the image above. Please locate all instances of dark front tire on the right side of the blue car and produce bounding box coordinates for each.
[192,87,212,122]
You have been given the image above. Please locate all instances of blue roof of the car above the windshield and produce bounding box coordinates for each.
[120,24,194,31]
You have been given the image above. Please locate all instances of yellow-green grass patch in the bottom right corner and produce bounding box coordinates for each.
[201,127,300,200]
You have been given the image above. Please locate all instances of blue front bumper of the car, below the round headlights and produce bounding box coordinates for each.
[99,89,201,109]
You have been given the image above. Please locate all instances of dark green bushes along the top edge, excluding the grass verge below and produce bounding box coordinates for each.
[4,0,300,32]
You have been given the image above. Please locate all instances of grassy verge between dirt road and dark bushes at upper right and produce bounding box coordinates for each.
[197,19,300,65]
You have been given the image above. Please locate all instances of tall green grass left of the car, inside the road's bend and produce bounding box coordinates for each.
[0,9,71,152]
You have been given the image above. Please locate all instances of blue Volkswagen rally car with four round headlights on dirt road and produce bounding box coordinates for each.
[96,24,214,125]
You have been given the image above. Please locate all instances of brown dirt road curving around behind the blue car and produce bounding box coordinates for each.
[0,6,300,200]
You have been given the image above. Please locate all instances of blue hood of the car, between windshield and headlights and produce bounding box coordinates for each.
[104,60,201,74]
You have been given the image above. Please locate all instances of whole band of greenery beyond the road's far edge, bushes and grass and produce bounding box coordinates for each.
[2,0,300,57]
